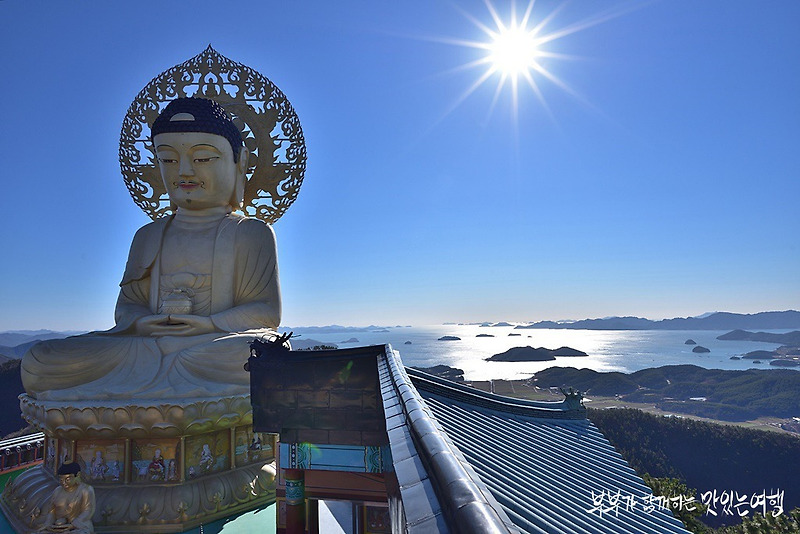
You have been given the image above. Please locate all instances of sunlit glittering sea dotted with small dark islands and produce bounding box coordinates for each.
[281,324,800,380]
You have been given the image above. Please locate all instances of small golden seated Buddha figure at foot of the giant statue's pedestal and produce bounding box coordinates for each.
[39,462,95,534]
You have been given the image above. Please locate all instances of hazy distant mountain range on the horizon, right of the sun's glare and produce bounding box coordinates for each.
[515,310,800,330]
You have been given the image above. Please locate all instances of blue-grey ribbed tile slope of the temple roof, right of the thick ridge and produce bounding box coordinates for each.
[408,370,687,534]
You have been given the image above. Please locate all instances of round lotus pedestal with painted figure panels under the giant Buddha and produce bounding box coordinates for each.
[0,395,276,533]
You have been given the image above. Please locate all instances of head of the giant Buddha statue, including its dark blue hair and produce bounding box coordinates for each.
[151,98,248,214]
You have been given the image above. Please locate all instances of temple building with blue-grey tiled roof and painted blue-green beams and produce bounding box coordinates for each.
[248,343,687,534]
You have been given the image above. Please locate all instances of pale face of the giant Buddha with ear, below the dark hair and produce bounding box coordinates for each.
[153,132,247,210]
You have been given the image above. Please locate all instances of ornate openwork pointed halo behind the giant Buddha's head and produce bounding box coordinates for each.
[119,45,306,223]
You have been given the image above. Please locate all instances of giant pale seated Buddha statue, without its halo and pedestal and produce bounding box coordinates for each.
[21,98,281,400]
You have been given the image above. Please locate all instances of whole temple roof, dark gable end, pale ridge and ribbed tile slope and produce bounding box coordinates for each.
[250,345,688,534]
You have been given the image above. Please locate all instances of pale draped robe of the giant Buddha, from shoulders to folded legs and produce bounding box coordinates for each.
[22,211,281,400]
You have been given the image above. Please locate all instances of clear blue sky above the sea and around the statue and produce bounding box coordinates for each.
[0,0,800,330]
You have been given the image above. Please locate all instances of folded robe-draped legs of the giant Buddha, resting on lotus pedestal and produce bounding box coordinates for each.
[22,330,274,400]
